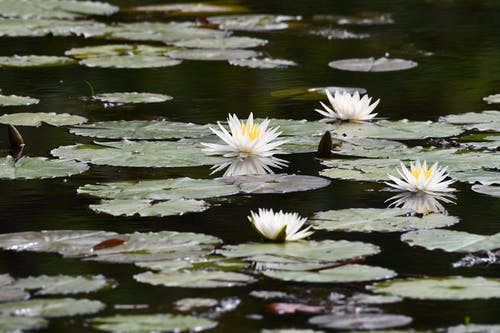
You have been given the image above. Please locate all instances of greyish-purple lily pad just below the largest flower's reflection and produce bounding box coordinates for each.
[220,174,330,193]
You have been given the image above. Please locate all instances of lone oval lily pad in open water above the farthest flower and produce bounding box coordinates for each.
[328,57,418,72]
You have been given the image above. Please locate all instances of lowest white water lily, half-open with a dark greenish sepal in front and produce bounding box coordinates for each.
[248,208,313,242]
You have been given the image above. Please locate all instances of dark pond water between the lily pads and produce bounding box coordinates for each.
[0,0,500,332]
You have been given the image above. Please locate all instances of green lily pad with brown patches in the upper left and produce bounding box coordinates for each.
[64,44,173,59]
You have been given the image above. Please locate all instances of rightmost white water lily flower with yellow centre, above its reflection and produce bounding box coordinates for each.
[386,160,455,194]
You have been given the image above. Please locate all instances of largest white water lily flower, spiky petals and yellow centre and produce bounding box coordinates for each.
[202,113,287,160]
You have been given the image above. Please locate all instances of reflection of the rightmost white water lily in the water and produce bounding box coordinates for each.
[386,192,455,215]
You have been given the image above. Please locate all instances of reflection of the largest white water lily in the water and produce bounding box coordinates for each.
[212,156,288,177]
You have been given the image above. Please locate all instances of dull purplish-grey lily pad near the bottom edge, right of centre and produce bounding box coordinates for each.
[309,313,412,330]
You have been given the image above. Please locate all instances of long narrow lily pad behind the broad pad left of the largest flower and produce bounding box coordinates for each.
[70,120,210,140]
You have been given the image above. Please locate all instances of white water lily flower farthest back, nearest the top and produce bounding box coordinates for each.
[315,89,380,121]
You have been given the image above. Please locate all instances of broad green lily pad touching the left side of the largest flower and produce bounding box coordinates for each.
[51,141,224,168]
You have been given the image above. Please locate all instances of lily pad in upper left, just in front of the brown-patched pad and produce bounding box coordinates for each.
[79,55,182,68]
